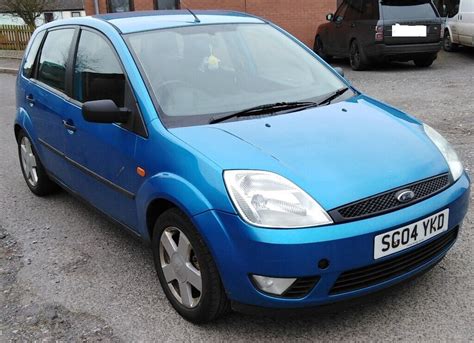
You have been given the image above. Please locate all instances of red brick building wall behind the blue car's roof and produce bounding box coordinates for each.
[84,0,337,47]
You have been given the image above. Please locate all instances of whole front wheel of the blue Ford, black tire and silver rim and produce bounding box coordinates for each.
[152,208,230,324]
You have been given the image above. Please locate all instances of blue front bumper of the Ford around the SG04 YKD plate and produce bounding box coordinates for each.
[193,174,469,308]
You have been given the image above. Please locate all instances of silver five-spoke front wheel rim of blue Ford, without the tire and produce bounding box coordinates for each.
[160,227,202,308]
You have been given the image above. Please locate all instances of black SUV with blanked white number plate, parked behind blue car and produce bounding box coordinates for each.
[314,0,441,70]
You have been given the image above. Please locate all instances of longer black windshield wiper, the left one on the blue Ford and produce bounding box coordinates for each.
[209,101,319,124]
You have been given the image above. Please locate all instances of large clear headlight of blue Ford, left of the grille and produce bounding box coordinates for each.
[224,170,332,228]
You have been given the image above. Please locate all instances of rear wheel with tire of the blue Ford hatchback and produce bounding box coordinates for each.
[17,130,59,196]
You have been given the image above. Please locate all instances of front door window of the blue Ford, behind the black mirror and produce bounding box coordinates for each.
[73,30,126,107]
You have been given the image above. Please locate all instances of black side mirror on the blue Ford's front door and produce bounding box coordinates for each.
[82,100,131,124]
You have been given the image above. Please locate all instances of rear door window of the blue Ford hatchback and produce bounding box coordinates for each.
[38,28,75,91]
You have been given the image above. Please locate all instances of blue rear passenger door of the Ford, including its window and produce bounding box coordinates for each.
[24,27,77,185]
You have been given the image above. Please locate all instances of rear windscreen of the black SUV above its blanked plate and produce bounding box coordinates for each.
[382,0,438,20]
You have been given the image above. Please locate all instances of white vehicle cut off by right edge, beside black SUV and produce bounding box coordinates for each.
[443,0,474,51]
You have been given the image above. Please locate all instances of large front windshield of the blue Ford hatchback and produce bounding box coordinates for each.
[127,24,352,127]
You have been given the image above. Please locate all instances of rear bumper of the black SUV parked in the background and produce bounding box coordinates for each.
[366,42,441,59]
